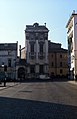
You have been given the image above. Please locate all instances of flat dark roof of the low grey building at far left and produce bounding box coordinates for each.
[0,43,17,50]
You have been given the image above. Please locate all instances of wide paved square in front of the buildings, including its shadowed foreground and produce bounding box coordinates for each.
[0,82,77,119]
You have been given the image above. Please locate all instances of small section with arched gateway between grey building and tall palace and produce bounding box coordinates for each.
[16,45,27,80]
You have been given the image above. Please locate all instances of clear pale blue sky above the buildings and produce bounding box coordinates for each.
[0,0,77,49]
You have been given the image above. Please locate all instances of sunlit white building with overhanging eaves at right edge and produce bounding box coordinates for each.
[66,11,77,79]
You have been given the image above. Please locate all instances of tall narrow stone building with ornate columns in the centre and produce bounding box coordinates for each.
[25,23,49,78]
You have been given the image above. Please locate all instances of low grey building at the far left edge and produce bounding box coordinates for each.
[0,42,18,79]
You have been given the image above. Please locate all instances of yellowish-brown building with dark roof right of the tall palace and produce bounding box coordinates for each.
[48,41,68,77]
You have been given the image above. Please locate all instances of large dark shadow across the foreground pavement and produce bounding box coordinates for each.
[0,97,77,119]
